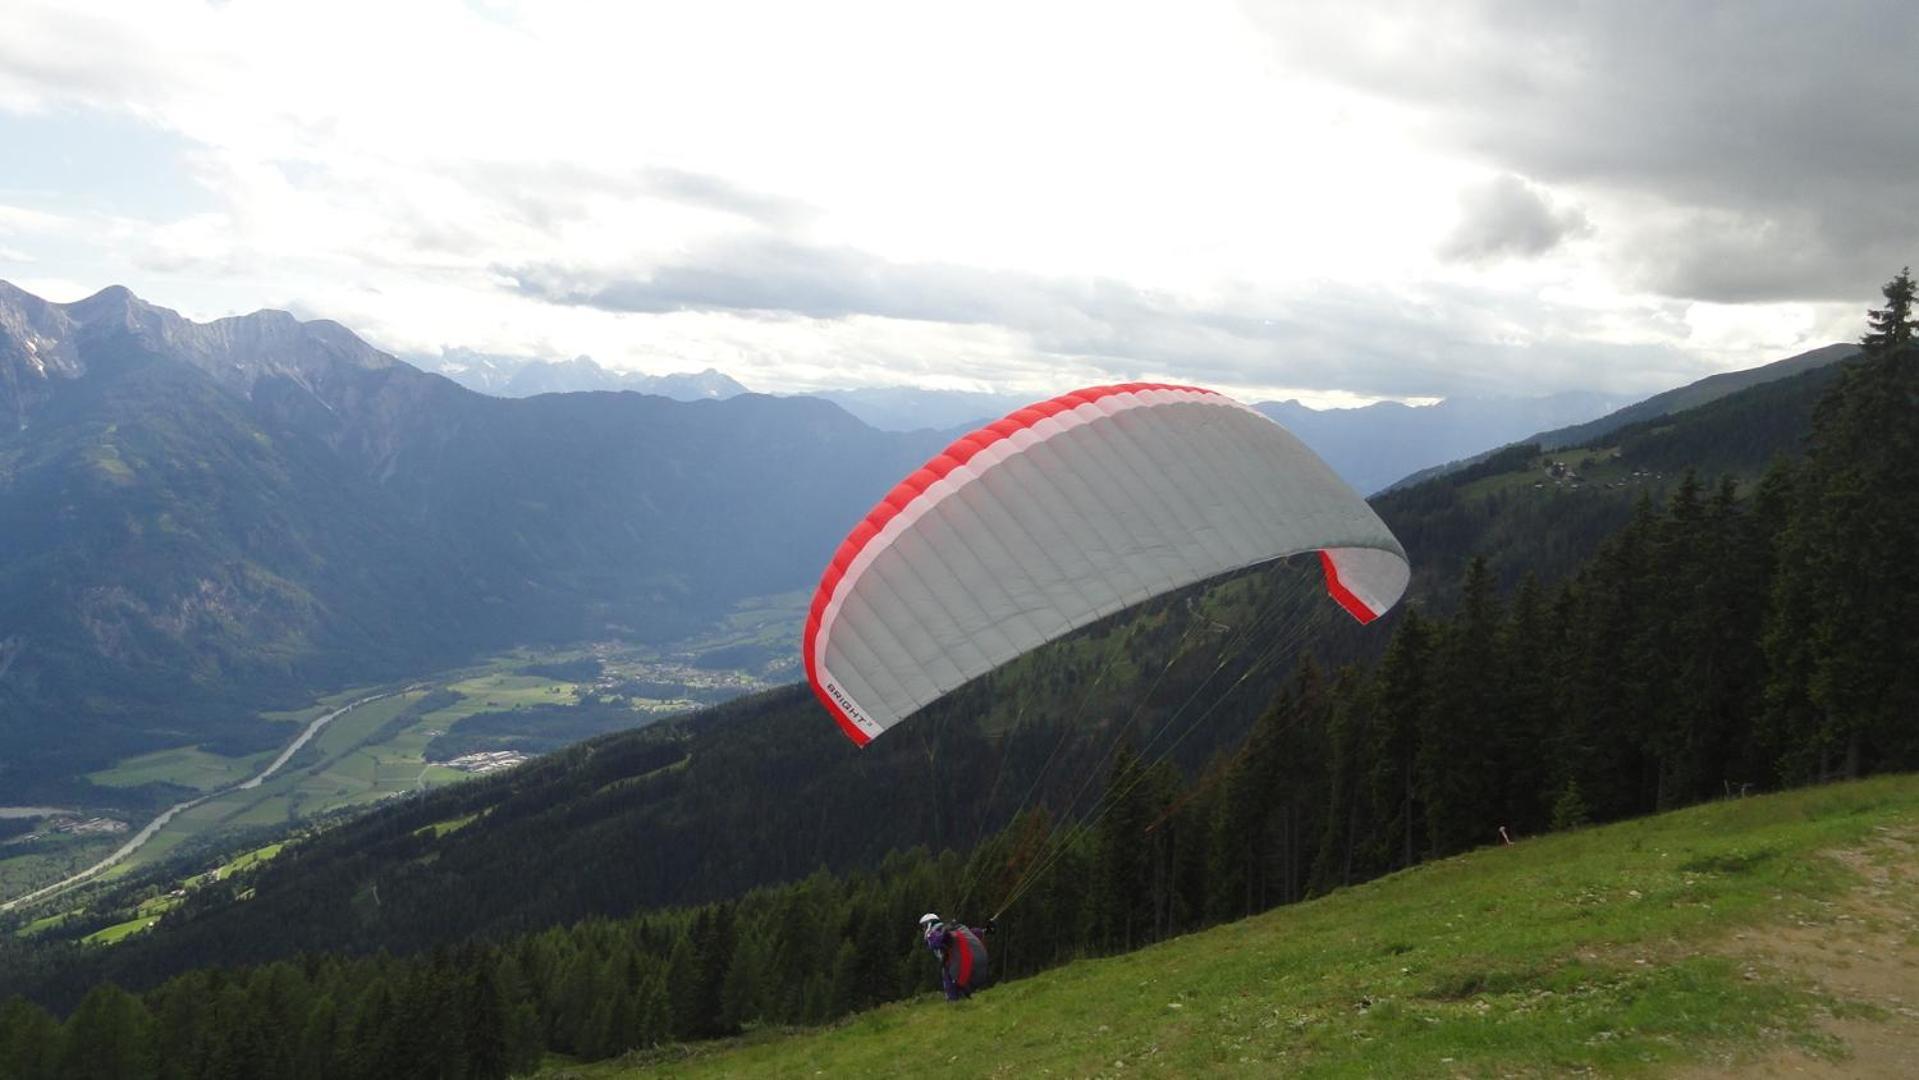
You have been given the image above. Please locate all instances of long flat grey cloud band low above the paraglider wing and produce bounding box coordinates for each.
[499,238,1696,397]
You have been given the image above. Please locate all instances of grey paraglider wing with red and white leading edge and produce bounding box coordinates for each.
[802,384,1410,746]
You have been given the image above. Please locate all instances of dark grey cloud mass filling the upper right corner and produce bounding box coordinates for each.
[1249,0,1919,301]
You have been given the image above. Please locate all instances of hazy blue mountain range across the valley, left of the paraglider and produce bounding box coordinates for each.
[0,284,938,796]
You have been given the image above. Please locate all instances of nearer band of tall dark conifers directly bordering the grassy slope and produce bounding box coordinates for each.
[0,272,1919,1080]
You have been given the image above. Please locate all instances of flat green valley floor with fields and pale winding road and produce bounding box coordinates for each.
[0,595,806,913]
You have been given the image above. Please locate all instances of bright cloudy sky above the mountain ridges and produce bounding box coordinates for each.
[0,0,1919,407]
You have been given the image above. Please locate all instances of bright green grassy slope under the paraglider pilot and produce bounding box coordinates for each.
[583,777,1919,1076]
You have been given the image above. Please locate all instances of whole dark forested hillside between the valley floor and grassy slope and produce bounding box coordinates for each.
[0,274,1919,1076]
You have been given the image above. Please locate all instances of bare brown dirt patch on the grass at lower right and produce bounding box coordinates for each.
[1681,829,1919,1080]
